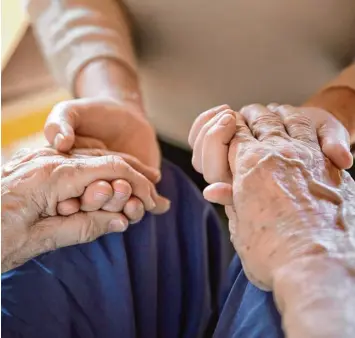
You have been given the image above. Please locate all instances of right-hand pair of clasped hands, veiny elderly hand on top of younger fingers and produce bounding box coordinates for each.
[189,104,355,290]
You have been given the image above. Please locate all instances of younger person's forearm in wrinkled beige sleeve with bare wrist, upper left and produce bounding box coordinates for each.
[26,0,142,110]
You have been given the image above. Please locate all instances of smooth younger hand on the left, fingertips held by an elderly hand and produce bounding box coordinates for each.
[44,98,161,215]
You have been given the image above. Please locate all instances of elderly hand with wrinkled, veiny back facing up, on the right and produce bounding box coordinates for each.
[214,105,355,289]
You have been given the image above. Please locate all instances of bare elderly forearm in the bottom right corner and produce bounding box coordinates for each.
[273,254,355,338]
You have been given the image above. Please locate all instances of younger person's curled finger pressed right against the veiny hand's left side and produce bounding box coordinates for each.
[202,114,236,183]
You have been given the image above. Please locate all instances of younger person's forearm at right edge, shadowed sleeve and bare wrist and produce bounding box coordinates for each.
[304,64,355,144]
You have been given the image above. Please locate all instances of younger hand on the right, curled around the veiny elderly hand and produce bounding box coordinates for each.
[189,104,352,184]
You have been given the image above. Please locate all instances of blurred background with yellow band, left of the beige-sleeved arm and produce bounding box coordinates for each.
[1,0,70,161]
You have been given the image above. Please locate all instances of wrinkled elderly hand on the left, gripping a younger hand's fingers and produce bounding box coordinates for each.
[1,148,169,272]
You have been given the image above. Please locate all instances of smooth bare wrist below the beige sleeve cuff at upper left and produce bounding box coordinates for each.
[75,59,144,113]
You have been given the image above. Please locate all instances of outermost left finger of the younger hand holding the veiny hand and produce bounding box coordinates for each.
[192,109,234,173]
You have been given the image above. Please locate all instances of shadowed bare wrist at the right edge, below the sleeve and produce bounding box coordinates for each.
[303,86,355,143]
